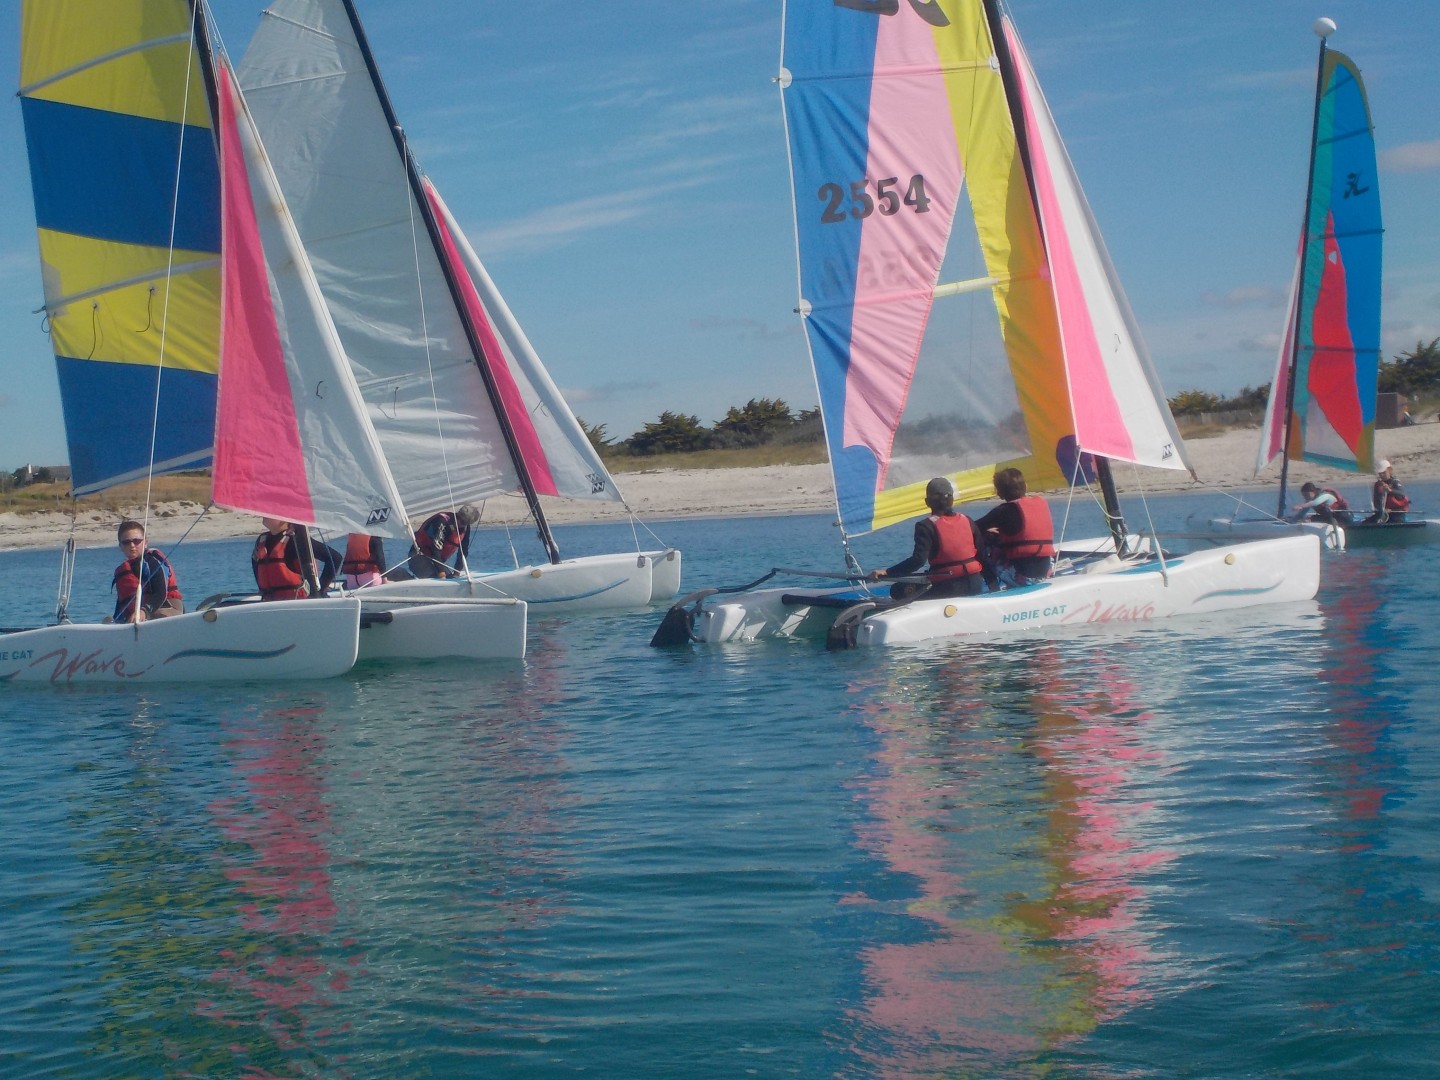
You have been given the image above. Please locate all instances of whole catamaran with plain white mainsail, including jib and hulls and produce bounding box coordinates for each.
[240,0,681,613]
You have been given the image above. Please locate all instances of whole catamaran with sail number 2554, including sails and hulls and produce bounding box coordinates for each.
[652,0,1319,647]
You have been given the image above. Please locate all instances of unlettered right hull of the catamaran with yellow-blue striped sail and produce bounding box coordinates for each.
[359,596,527,662]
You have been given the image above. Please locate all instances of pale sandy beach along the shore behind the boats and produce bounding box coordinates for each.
[0,423,1440,550]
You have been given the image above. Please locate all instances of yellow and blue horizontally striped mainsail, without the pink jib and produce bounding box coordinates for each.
[20,0,220,494]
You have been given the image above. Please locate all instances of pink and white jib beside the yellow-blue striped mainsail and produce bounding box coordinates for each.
[213,58,410,541]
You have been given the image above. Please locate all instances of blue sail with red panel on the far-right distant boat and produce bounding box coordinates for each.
[1256,45,1382,472]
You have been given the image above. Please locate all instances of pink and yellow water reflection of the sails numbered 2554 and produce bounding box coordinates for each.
[850,641,1171,1076]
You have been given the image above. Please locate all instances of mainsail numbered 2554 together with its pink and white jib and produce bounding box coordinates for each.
[780,0,1187,534]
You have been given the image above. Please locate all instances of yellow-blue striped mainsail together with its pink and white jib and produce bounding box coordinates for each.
[22,0,409,537]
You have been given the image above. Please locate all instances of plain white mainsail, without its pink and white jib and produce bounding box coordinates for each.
[239,0,518,516]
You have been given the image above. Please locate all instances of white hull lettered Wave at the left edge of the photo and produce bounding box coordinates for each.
[0,598,360,684]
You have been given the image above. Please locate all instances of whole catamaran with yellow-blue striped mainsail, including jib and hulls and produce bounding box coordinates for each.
[0,0,526,684]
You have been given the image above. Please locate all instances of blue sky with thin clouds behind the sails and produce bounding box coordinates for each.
[0,0,1440,471]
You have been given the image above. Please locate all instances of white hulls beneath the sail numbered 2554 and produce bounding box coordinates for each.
[694,536,1320,645]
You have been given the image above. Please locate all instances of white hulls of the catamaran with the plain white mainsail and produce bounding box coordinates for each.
[360,549,680,615]
